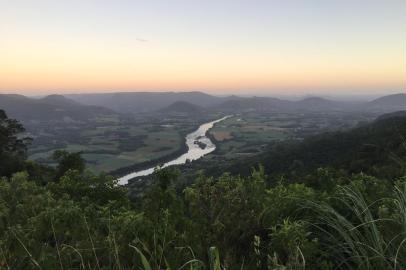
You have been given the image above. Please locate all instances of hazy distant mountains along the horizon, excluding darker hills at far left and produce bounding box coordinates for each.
[66,92,406,113]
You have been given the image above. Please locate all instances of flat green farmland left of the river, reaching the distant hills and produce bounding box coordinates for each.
[28,112,219,172]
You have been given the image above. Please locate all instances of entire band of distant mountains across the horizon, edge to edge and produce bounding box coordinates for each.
[0,92,406,120]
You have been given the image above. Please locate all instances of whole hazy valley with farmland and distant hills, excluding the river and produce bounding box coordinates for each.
[0,92,394,175]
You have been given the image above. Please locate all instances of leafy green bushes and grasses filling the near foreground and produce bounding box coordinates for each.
[0,132,406,270]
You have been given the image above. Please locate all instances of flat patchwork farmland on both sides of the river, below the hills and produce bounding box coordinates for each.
[27,112,374,172]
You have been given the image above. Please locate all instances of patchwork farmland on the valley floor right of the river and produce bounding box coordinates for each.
[209,112,370,158]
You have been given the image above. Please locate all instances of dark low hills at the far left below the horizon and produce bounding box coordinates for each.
[0,94,117,121]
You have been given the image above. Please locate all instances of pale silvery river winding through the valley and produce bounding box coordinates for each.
[118,116,231,185]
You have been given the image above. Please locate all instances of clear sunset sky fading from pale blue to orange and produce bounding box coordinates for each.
[0,0,406,95]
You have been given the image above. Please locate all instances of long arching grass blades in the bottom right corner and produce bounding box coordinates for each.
[309,186,406,270]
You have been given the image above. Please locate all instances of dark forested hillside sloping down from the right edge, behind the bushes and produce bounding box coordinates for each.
[185,112,406,184]
